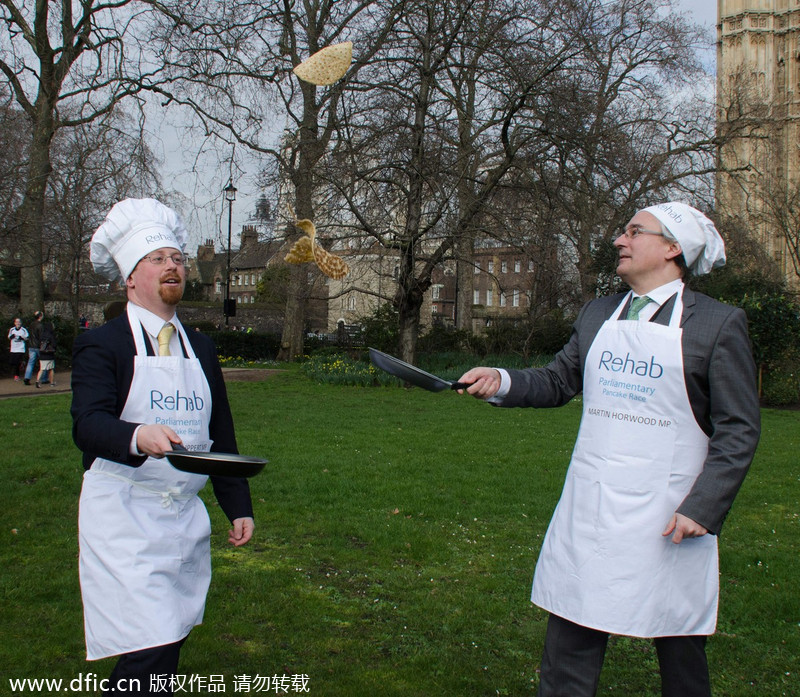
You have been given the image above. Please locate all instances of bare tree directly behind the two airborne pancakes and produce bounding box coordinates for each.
[142,0,402,359]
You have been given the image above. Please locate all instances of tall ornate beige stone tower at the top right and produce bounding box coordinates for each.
[717,0,800,287]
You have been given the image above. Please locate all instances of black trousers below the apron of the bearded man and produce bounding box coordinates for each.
[103,637,186,697]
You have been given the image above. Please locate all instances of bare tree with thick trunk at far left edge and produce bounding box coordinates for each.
[0,0,150,312]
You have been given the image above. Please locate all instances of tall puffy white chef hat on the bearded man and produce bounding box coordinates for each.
[90,198,188,283]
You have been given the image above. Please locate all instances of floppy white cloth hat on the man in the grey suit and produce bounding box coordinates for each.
[642,201,725,276]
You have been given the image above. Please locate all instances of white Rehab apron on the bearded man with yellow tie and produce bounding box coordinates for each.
[78,311,211,660]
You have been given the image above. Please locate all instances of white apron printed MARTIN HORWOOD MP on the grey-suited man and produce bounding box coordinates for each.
[531,293,719,637]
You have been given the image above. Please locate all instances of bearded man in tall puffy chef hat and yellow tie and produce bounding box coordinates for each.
[72,199,253,694]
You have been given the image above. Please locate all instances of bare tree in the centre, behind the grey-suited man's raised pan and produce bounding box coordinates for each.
[328,0,571,360]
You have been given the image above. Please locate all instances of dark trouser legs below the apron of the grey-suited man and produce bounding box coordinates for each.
[538,615,711,697]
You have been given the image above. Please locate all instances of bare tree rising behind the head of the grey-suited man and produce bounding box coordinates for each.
[512,0,719,300]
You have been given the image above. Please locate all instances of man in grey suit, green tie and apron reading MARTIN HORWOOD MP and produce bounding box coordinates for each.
[460,202,760,697]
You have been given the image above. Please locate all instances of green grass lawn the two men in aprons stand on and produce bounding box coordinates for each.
[0,369,800,697]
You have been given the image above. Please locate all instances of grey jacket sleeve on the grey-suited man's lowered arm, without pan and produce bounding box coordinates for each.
[678,301,761,534]
